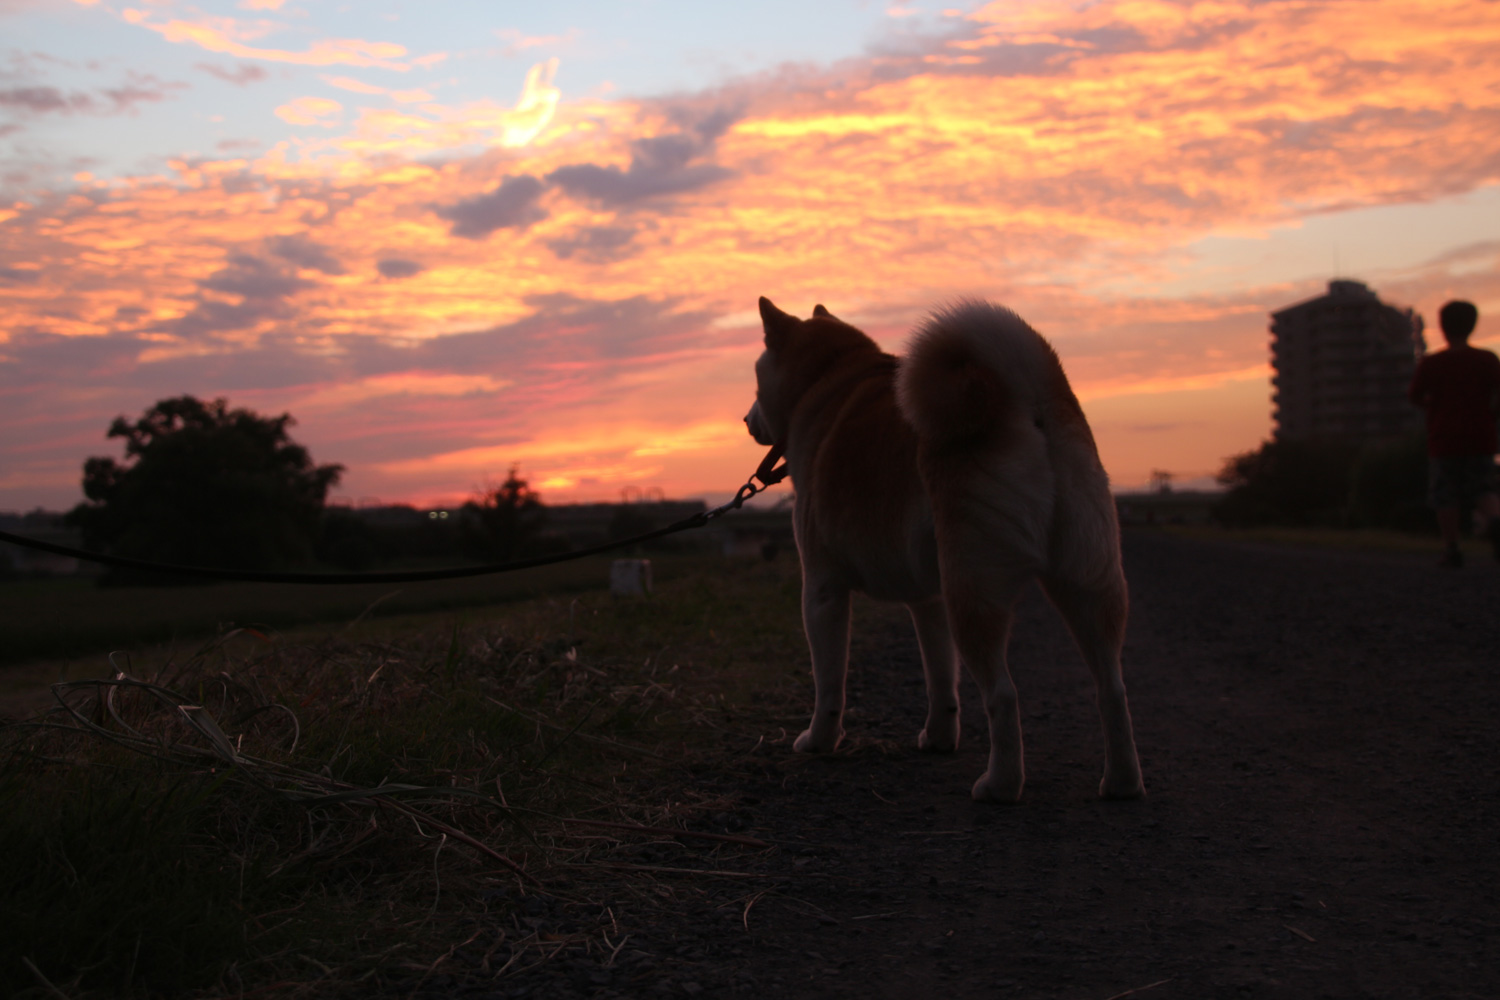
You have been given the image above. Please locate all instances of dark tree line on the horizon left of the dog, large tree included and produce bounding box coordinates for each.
[66,396,702,585]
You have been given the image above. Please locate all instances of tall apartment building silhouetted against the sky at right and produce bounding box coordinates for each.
[1271,279,1427,444]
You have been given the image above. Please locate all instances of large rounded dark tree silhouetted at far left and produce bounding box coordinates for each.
[69,396,344,582]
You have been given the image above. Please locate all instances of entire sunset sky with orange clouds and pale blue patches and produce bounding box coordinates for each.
[0,0,1500,510]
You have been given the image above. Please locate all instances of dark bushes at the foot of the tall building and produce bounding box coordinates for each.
[1214,430,1437,532]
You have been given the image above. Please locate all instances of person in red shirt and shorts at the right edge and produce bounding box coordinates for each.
[1407,301,1500,568]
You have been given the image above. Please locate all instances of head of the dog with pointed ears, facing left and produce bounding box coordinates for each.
[746,295,879,445]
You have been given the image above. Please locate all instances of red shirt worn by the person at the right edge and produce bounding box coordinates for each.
[1407,343,1500,459]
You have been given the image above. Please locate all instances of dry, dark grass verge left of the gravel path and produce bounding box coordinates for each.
[0,561,807,1000]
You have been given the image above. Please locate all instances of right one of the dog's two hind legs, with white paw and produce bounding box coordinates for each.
[1043,574,1145,799]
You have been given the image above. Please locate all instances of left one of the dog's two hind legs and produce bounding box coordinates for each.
[944,576,1026,802]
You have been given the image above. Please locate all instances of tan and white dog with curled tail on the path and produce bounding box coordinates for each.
[746,298,1145,802]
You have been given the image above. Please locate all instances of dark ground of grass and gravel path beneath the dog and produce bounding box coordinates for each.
[0,531,1500,1000]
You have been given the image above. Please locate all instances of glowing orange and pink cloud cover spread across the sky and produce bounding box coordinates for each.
[0,0,1500,499]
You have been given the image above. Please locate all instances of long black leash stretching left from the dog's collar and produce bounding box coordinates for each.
[0,445,786,583]
